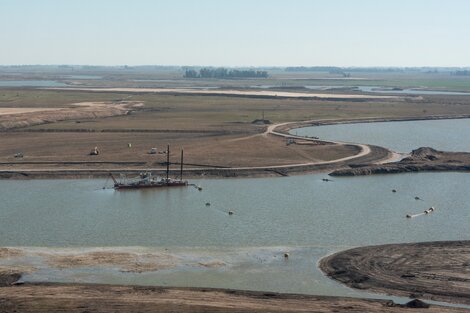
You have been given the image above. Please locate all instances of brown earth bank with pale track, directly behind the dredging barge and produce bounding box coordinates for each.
[0,146,390,179]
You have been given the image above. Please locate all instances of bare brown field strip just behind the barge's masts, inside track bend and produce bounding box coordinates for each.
[0,132,358,169]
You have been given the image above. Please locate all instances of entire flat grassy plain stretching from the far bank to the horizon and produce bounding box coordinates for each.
[0,68,470,173]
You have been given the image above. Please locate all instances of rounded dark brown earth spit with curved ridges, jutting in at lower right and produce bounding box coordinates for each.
[320,241,470,304]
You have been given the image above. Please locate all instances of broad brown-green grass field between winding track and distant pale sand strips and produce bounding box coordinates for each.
[0,90,470,169]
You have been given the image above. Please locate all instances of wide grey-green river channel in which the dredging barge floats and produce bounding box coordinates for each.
[0,120,470,298]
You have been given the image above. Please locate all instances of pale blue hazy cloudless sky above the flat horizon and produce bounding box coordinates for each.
[0,0,470,66]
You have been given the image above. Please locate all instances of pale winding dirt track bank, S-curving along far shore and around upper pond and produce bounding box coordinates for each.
[0,114,470,179]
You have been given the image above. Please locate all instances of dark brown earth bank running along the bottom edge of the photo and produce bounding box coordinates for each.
[0,273,464,313]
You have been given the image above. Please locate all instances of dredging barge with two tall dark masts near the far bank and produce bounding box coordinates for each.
[109,146,188,190]
